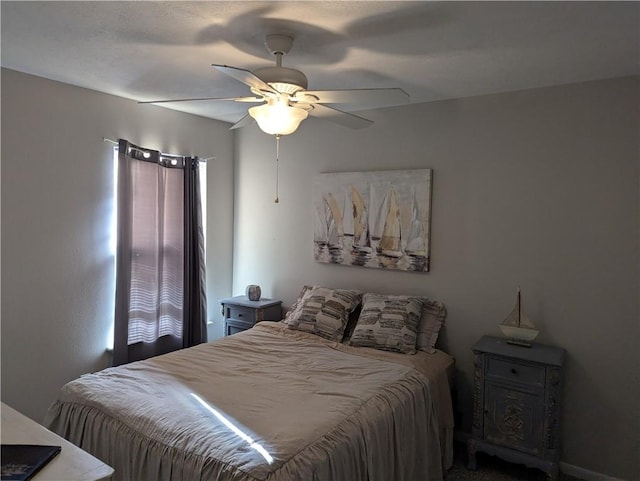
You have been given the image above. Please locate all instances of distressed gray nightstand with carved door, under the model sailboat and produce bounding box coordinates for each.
[467,336,565,480]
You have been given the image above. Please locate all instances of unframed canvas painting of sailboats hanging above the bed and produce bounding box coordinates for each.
[313,169,433,272]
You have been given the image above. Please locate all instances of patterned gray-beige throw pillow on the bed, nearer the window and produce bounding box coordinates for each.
[284,286,362,341]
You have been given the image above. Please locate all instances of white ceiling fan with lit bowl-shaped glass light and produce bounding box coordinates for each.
[139,34,409,137]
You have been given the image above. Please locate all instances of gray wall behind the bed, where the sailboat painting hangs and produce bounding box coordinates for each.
[233,79,640,481]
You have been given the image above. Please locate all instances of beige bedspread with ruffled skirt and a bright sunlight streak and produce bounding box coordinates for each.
[46,322,453,481]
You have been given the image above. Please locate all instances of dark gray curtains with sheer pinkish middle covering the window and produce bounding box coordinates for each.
[113,139,206,365]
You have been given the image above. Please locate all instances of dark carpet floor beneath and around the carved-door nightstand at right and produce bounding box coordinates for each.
[445,442,582,481]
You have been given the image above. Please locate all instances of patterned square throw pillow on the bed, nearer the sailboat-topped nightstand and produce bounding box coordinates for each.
[349,293,425,354]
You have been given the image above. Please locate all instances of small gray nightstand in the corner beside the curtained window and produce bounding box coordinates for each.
[220,296,282,336]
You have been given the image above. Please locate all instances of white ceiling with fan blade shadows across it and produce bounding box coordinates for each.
[0,0,640,122]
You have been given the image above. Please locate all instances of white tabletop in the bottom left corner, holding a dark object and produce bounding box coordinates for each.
[0,403,113,481]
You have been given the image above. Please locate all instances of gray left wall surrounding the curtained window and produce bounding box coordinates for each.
[2,69,233,421]
